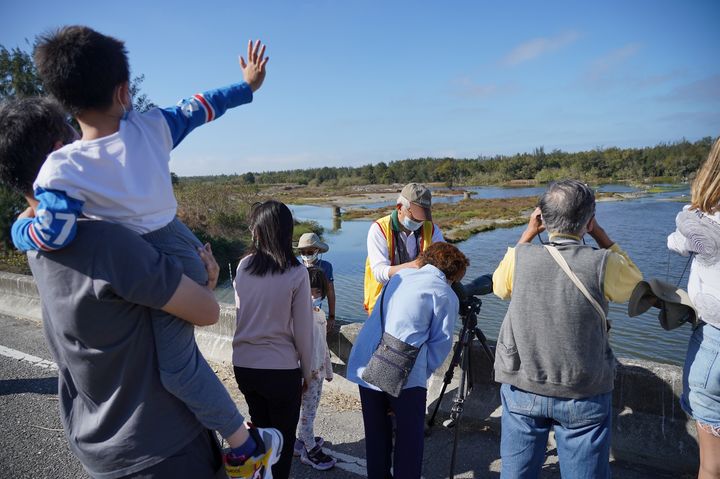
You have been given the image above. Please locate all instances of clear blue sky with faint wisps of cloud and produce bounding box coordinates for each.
[0,0,720,175]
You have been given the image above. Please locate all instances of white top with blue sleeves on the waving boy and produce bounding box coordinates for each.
[12,83,253,251]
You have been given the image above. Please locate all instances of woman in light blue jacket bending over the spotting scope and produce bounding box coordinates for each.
[347,243,469,479]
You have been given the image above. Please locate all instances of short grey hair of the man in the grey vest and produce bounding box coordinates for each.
[540,180,595,235]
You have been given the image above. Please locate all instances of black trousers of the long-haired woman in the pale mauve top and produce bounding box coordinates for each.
[234,367,302,479]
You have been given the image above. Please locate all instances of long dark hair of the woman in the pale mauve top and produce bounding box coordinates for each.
[245,200,300,276]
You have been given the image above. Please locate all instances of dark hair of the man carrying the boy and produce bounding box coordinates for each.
[0,97,73,195]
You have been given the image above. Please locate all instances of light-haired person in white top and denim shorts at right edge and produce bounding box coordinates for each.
[668,139,720,479]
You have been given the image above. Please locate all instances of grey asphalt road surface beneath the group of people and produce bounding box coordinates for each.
[0,315,692,479]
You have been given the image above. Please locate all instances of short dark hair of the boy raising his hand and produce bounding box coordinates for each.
[34,25,130,115]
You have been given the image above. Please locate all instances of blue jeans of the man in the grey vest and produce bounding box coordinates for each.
[500,384,612,479]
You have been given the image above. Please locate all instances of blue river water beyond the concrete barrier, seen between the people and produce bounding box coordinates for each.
[218,185,691,365]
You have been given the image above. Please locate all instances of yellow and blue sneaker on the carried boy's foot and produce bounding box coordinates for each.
[223,427,283,479]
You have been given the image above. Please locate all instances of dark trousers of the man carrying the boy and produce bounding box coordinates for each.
[125,429,223,479]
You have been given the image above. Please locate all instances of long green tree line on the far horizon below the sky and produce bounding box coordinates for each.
[223,137,714,187]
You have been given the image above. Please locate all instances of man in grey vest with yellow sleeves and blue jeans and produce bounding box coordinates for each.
[493,180,642,478]
